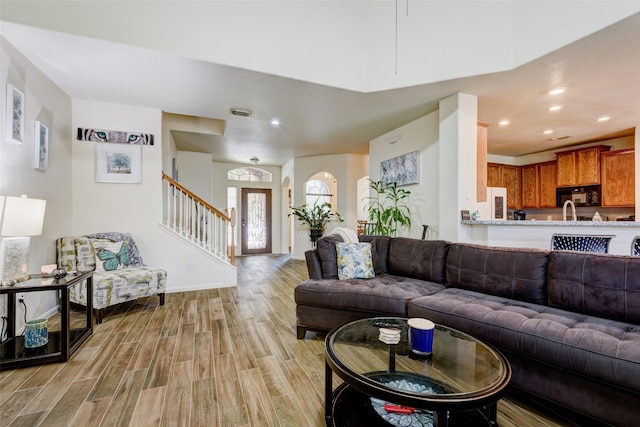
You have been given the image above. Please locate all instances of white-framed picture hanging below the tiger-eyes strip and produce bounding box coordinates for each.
[96,144,142,184]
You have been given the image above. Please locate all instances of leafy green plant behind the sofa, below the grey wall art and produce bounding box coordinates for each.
[367,179,411,237]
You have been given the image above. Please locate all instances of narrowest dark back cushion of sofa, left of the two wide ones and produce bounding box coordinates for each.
[387,237,449,283]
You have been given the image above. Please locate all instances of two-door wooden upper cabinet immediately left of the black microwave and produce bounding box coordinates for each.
[520,161,556,208]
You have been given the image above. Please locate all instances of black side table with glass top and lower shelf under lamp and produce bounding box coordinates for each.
[0,271,93,371]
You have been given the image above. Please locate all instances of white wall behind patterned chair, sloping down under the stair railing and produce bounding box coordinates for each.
[70,100,236,292]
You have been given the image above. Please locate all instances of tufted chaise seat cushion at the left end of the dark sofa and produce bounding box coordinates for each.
[294,274,445,316]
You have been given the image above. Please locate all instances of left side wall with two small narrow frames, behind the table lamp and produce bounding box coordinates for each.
[0,37,73,328]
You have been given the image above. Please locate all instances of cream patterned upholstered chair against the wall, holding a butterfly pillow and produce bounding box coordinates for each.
[56,233,167,324]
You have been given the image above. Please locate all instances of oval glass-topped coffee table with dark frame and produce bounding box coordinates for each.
[325,317,511,427]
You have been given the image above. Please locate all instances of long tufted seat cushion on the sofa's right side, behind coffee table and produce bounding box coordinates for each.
[408,288,640,392]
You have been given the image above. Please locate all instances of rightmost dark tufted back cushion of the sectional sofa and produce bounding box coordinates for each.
[547,251,640,324]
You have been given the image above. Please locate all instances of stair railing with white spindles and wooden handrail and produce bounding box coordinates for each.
[162,173,236,265]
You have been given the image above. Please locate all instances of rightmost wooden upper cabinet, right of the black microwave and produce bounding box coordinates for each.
[601,148,636,206]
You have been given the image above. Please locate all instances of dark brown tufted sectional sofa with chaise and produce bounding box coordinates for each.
[295,235,640,426]
